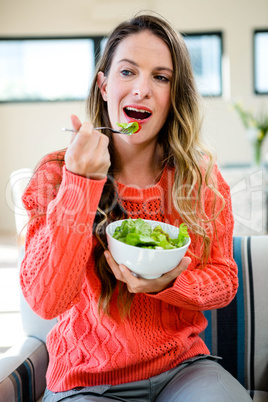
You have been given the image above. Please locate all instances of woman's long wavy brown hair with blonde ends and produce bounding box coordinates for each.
[33,14,224,313]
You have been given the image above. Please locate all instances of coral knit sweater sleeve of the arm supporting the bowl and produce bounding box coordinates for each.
[150,168,238,310]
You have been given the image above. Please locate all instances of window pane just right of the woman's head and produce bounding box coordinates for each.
[184,32,222,96]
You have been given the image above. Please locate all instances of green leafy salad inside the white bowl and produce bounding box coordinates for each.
[113,218,189,250]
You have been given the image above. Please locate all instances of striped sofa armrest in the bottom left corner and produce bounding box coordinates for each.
[0,337,48,402]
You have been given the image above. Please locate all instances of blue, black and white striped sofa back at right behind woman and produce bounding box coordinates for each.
[204,236,268,392]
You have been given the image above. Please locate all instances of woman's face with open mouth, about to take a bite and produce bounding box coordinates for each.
[98,31,173,142]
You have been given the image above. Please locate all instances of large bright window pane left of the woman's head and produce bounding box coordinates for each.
[0,37,102,102]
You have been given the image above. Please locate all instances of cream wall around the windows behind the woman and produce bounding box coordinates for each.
[0,0,268,231]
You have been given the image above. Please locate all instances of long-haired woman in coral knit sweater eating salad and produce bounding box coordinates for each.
[21,15,251,402]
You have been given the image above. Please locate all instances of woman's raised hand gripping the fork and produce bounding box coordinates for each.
[65,115,111,180]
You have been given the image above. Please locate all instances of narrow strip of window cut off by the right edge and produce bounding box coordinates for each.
[254,29,268,95]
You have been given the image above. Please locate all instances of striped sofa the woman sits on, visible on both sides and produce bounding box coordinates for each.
[0,235,268,402]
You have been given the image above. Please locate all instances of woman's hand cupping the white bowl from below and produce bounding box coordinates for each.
[104,250,191,293]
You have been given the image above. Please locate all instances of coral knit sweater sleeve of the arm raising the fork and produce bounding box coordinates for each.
[20,162,105,319]
